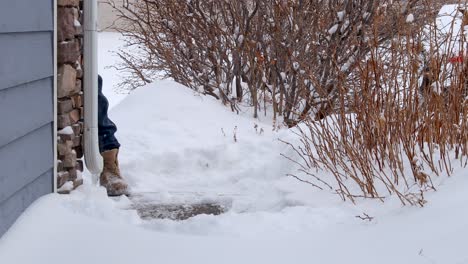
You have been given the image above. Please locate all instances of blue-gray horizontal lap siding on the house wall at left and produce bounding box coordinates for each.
[0,0,54,236]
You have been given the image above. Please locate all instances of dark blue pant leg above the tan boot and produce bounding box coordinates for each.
[98,75,120,152]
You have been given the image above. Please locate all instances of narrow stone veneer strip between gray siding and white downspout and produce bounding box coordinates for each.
[57,0,84,194]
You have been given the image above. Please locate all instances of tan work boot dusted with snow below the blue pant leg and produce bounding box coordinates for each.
[100,149,128,196]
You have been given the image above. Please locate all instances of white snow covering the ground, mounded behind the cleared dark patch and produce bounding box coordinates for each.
[0,33,468,264]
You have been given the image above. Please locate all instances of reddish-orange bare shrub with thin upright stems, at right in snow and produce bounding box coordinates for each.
[291,3,468,206]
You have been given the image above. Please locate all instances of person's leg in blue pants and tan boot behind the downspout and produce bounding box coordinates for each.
[98,76,128,196]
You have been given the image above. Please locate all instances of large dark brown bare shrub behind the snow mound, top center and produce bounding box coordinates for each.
[111,0,440,127]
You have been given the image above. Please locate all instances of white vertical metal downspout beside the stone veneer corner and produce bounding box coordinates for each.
[83,0,103,179]
